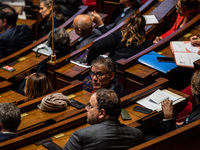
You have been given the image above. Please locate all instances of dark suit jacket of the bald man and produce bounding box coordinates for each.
[77,29,102,49]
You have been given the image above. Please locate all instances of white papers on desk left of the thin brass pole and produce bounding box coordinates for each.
[32,42,52,56]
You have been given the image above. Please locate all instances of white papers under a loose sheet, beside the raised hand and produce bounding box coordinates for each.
[137,89,185,112]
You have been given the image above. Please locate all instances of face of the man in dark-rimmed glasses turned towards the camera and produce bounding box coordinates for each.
[91,66,114,89]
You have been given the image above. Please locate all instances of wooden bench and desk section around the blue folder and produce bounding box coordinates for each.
[117,15,200,92]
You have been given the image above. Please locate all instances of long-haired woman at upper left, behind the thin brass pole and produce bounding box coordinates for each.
[39,0,64,38]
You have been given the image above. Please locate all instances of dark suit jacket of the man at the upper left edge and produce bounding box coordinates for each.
[0,25,33,58]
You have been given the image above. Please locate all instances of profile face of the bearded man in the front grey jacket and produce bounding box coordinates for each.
[85,93,100,124]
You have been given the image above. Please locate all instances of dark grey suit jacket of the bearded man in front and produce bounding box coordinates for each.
[63,120,142,150]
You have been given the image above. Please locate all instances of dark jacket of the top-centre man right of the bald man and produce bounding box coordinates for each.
[98,1,142,34]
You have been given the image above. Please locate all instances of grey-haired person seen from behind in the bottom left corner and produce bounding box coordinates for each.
[0,103,21,142]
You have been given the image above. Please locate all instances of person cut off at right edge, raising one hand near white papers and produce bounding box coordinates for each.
[161,70,200,132]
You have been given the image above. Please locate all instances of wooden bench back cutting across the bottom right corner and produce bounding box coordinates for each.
[131,120,200,150]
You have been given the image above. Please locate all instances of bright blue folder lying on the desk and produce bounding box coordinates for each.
[138,51,177,74]
